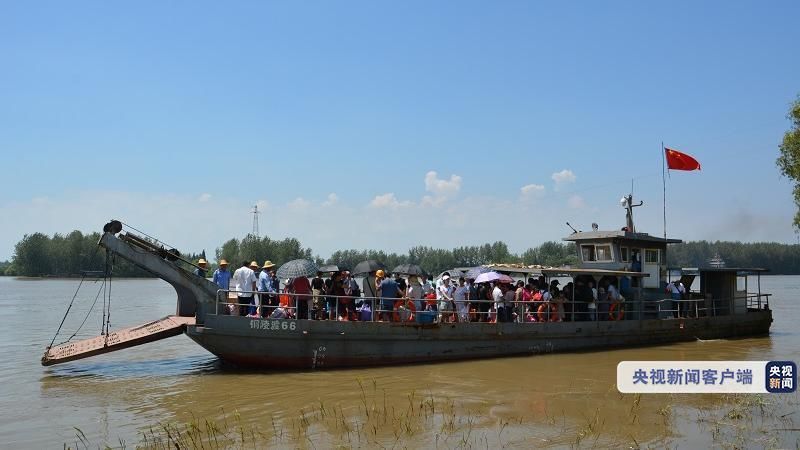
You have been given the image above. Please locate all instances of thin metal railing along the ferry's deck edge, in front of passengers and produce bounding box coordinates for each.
[211,289,770,323]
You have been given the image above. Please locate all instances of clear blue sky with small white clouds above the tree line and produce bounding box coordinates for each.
[0,1,800,260]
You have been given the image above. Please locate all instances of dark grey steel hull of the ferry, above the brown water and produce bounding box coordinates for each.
[186,310,772,369]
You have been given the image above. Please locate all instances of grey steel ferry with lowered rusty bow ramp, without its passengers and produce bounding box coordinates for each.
[42,195,772,369]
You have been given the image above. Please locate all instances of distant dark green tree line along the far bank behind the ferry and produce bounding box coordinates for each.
[0,230,800,277]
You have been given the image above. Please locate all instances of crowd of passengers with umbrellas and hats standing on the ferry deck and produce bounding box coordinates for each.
[195,259,627,322]
